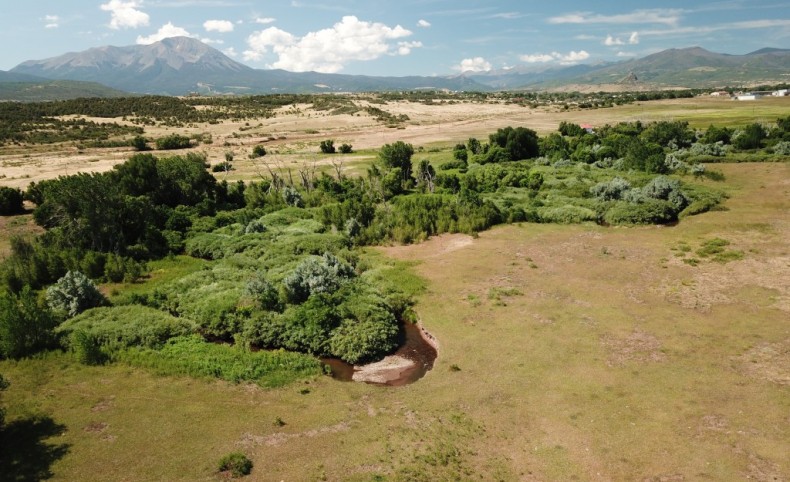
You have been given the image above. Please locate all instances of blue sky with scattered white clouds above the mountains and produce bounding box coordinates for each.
[0,0,790,76]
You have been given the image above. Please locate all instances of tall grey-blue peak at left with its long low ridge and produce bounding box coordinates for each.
[11,37,486,95]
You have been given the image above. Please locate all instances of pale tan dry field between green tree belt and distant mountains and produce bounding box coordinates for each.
[0,97,790,188]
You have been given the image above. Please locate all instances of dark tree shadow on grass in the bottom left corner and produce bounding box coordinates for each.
[0,416,69,482]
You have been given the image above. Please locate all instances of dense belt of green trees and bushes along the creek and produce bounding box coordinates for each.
[0,111,790,381]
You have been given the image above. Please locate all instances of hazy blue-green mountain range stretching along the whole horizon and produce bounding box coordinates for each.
[0,37,790,98]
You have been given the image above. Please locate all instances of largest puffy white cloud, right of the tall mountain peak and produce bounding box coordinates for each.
[243,16,422,73]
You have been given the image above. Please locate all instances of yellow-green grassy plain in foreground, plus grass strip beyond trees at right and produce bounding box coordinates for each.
[0,99,790,481]
